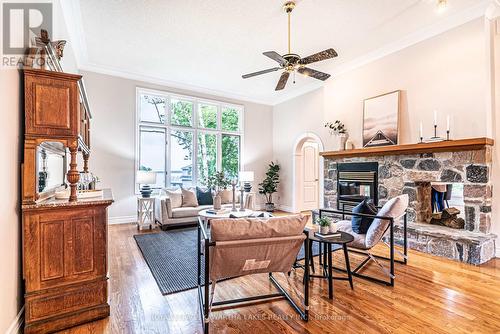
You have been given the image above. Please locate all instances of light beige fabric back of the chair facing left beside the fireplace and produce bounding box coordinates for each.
[366,194,408,248]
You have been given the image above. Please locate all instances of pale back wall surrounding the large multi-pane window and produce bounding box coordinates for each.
[83,72,273,221]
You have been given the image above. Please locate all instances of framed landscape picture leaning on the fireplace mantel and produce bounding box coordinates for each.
[363,90,401,147]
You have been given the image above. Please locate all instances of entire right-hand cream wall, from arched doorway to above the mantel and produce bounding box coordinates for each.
[273,18,487,211]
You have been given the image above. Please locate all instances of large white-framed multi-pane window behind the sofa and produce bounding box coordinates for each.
[136,88,243,188]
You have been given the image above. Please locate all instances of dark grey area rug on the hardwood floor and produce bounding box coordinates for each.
[134,227,319,295]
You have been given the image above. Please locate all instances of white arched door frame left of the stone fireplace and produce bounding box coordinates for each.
[292,132,325,212]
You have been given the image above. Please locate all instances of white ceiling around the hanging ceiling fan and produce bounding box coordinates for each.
[72,0,489,104]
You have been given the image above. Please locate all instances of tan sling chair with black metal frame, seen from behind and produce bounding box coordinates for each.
[197,215,310,334]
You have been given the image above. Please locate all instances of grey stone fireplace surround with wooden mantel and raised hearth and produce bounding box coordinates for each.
[322,138,496,264]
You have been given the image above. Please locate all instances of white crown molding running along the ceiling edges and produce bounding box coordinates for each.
[61,0,490,106]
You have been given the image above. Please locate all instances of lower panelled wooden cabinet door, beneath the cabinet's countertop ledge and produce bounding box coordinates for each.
[24,208,106,292]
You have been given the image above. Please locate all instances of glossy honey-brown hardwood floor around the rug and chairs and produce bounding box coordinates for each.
[62,220,500,334]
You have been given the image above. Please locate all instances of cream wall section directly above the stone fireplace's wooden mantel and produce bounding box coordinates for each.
[324,19,487,147]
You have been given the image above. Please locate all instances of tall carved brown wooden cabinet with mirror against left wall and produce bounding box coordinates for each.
[22,69,113,333]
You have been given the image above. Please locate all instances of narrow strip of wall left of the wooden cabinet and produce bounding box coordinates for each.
[0,69,23,333]
